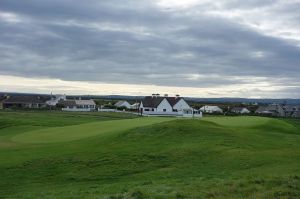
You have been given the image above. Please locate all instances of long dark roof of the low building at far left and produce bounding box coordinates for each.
[3,95,50,104]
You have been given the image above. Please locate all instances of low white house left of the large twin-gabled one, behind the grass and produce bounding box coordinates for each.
[61,100,96,112]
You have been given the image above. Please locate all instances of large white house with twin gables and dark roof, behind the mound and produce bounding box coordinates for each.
[139,95,202,117]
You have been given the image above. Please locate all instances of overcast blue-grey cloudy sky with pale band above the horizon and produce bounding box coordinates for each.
[0,0,300,98]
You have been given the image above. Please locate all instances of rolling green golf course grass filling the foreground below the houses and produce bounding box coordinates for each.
[0,112,300,199]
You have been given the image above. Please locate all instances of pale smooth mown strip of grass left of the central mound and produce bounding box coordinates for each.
[12,117,174,143]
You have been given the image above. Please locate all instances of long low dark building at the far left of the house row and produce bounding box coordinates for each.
[2,95,50,108]
